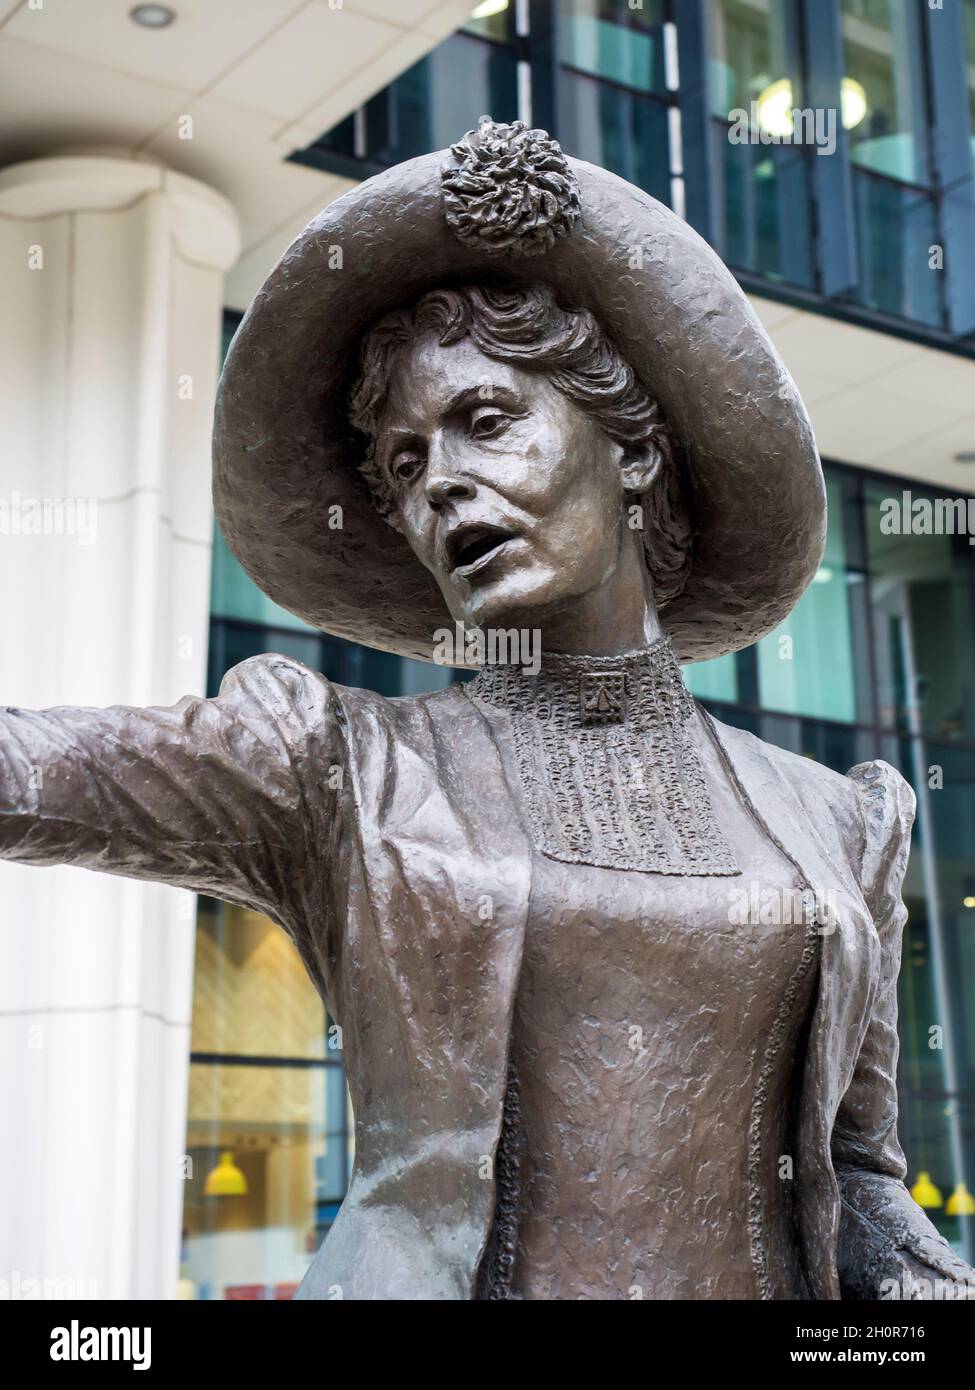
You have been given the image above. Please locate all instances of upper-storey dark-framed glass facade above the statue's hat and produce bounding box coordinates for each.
[293,0,975,344]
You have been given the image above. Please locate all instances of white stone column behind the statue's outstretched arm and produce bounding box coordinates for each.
[0,154,239,1298]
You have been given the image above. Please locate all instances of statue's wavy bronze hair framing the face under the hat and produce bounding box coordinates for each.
[349,284,693,607]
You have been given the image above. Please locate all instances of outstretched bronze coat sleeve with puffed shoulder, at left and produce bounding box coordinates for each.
[0,656,342,934]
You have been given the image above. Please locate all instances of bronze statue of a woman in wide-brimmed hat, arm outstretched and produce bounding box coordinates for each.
[0,118,975,1300]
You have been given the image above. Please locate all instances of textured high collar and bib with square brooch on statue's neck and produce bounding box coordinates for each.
[465,637,741,874]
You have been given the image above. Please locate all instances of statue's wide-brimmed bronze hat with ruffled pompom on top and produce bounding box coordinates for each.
[213,120,826,662]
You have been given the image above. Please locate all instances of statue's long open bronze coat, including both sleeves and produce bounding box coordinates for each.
[0,656,972,1300]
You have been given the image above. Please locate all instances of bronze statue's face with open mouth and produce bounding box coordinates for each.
[376,336,642,628]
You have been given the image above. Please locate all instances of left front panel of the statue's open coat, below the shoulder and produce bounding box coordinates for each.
[302,678,531,1300]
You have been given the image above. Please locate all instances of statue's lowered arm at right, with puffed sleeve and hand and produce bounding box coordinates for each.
[832,762,975,1298]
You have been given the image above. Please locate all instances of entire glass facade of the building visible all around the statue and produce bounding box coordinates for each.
[184,0,975,1298]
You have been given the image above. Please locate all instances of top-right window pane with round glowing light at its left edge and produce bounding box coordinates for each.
[841,0,929,183]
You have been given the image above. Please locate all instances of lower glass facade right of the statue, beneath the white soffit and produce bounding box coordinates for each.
[695,464,975,1251]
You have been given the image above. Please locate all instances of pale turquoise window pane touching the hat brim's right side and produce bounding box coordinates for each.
[758,478,857,721]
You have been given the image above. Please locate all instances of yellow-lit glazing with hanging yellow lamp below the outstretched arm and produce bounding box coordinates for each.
[181,899,350,1300]
